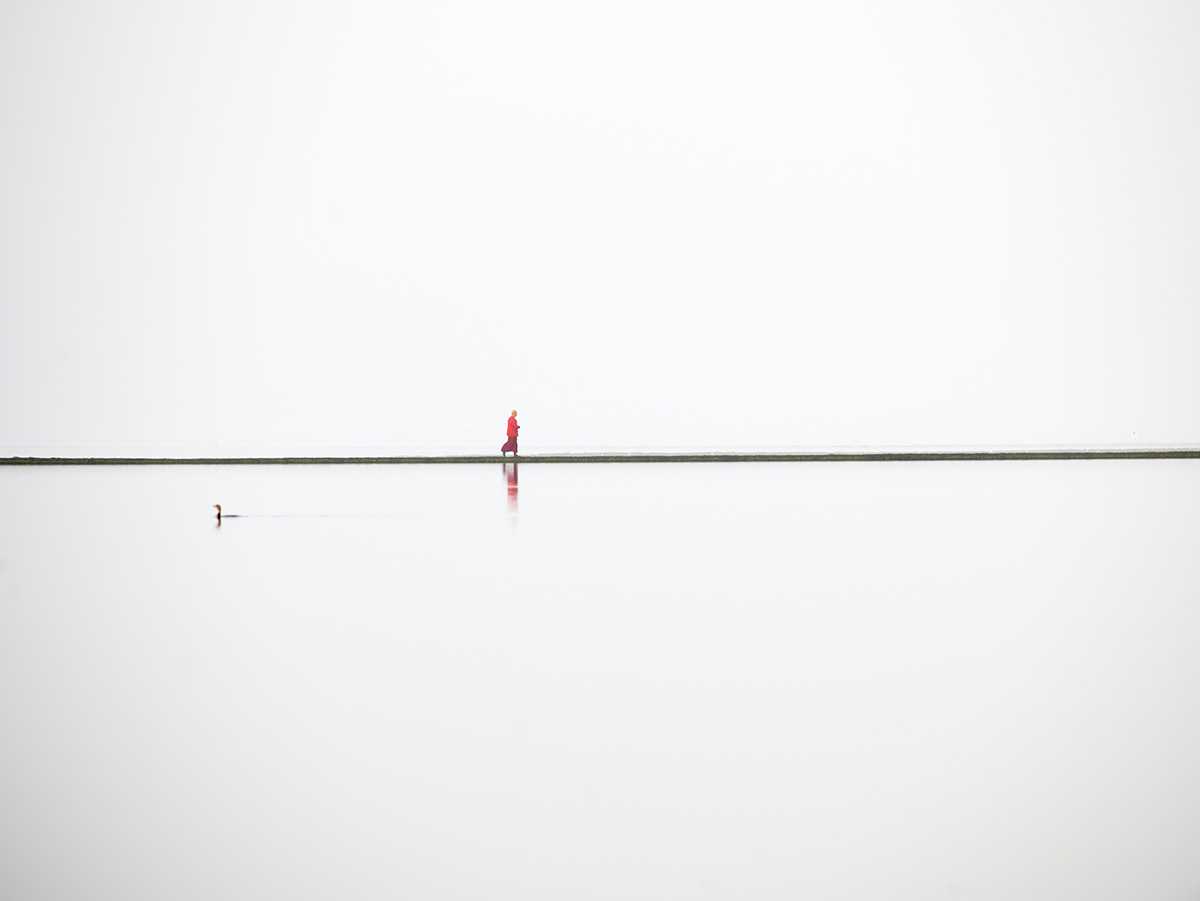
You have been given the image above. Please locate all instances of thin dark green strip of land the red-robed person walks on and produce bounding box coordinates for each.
[0,448,1200,465]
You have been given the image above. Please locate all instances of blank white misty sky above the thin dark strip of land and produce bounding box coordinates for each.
[0,0,1200,453]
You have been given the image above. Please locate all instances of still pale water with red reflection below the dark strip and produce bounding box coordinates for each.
[0,461,1200,901]
